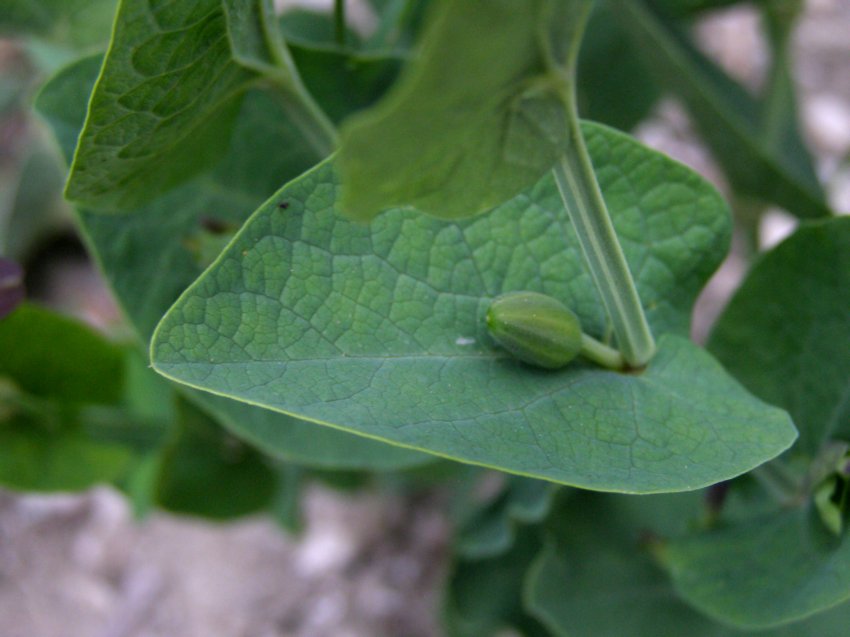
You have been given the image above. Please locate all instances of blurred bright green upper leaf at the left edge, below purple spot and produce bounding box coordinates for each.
[0,304,124,403]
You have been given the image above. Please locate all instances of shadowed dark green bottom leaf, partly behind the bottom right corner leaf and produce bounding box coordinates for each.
[525,493,850,637]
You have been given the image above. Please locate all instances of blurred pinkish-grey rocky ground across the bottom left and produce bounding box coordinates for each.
[0,488,448,637]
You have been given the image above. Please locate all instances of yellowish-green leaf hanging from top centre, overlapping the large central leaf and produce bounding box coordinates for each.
[339,0,584,220]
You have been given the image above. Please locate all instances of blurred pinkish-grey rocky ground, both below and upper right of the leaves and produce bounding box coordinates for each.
[0,0,850,637]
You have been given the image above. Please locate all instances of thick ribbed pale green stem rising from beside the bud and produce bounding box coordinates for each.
[552,3,655,367]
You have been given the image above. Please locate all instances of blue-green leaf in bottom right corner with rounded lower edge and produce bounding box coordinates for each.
[662,508,850,630]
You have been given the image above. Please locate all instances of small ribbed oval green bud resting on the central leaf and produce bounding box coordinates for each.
[487,292,582,369]
